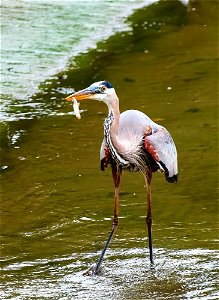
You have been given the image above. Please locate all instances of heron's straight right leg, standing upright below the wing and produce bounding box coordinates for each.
[145,170,153,264]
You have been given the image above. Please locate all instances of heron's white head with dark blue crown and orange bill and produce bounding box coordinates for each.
[66,81,118,105]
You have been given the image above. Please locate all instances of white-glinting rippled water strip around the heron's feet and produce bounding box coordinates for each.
[2,248,219,300]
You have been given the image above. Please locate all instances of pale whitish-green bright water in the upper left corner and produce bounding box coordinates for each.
[1,0,157,120]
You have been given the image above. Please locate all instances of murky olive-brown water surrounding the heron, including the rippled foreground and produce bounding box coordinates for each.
[1,1,219,300]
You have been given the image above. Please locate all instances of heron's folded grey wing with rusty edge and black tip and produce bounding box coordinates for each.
[145,126,178,182]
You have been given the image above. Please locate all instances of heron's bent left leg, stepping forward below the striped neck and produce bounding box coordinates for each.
[93,167,121,275]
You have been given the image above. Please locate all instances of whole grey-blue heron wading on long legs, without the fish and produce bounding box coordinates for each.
[66,81,178,274]
